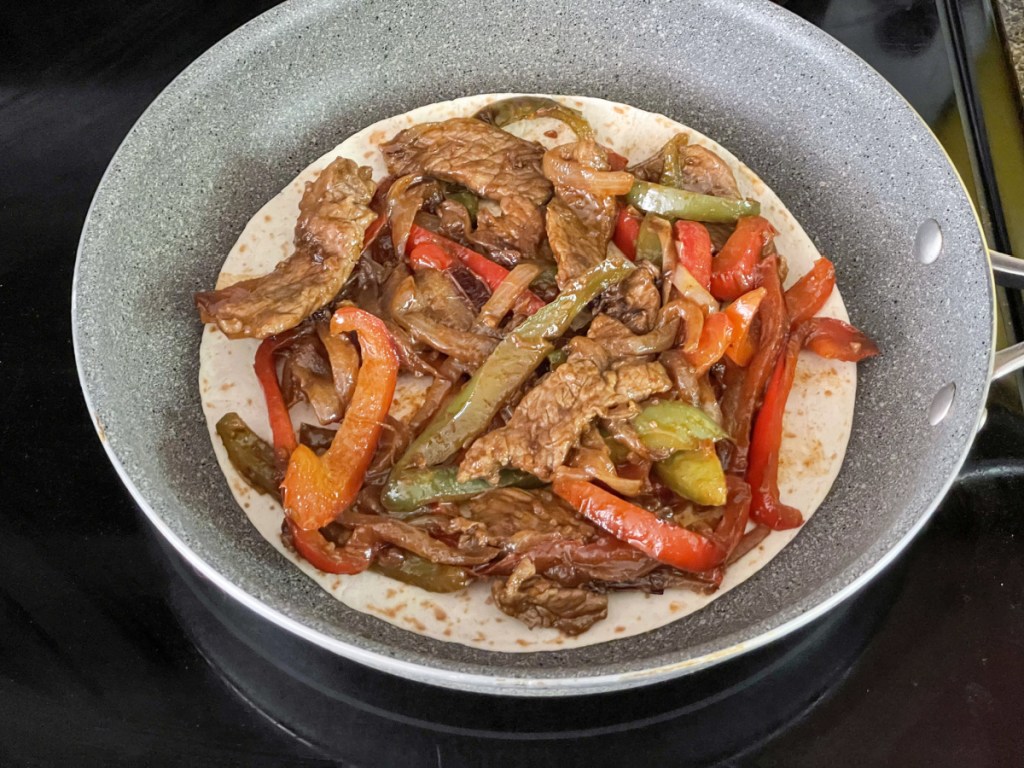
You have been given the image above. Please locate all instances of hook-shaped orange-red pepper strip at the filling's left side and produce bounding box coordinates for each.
[281,306,398,530]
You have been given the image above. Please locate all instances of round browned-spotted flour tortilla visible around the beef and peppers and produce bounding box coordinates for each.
[200,94,856,652]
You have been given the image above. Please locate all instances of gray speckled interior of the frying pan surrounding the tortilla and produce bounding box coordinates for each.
[73,0,993,695]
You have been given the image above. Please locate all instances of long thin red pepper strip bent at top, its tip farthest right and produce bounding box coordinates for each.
[746,317,879,530]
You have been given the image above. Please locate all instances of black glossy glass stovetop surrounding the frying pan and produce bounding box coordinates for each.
[0,0,1024,766]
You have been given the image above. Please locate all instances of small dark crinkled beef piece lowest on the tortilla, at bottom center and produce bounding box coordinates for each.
[490,559,608,636]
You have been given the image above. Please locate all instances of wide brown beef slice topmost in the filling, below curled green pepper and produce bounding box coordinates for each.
[381,118,551,205]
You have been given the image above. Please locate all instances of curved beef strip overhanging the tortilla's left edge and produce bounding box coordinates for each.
[196,158,377,339]
